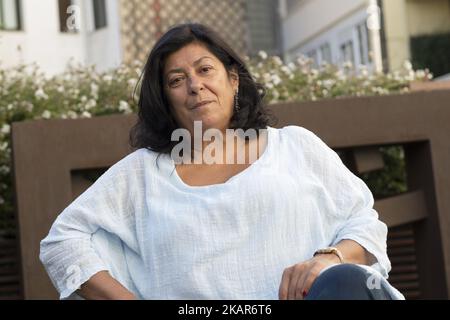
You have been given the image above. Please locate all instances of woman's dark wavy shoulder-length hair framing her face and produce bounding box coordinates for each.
[126,23,275,153]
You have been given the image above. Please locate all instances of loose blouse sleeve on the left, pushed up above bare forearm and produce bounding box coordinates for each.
[39,154,137,299]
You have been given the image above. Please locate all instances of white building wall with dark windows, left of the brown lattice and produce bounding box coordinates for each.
[0,0,122,74]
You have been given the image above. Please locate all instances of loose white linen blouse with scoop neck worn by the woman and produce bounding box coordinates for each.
[40,126,402,300]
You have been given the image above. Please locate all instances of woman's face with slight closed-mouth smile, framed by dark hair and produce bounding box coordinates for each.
[164,43,239,132]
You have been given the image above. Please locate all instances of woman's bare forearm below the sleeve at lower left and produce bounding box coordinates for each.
[77,271,136,300]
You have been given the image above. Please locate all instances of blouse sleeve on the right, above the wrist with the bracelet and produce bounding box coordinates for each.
[294,128,391,278]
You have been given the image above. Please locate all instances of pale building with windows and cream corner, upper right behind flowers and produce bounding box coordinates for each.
[280,0,450,70]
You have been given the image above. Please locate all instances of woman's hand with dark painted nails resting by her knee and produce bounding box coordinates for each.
[278,254,341,300]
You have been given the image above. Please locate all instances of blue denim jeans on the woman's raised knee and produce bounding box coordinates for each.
[305,264,394,300]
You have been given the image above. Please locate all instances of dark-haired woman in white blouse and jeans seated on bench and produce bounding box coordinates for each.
[40,24,403,299]
